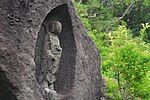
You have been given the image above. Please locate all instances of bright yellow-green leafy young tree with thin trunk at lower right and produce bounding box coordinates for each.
[103,26,150,100]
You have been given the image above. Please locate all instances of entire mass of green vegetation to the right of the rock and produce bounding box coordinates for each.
[73,0,150,100]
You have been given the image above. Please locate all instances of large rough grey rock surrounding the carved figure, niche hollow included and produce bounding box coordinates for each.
[0,0,102,100]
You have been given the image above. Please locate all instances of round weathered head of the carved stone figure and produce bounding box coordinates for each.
[49,21,62,34]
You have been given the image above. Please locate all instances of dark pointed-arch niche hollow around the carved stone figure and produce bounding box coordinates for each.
[35,4,76,94]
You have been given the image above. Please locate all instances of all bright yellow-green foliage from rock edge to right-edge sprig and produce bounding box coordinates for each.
[89,24,150,100]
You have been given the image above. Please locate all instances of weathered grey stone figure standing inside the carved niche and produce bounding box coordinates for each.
[43,21,62,93]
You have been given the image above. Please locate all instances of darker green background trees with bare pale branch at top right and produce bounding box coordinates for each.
[77,0,150,35]
